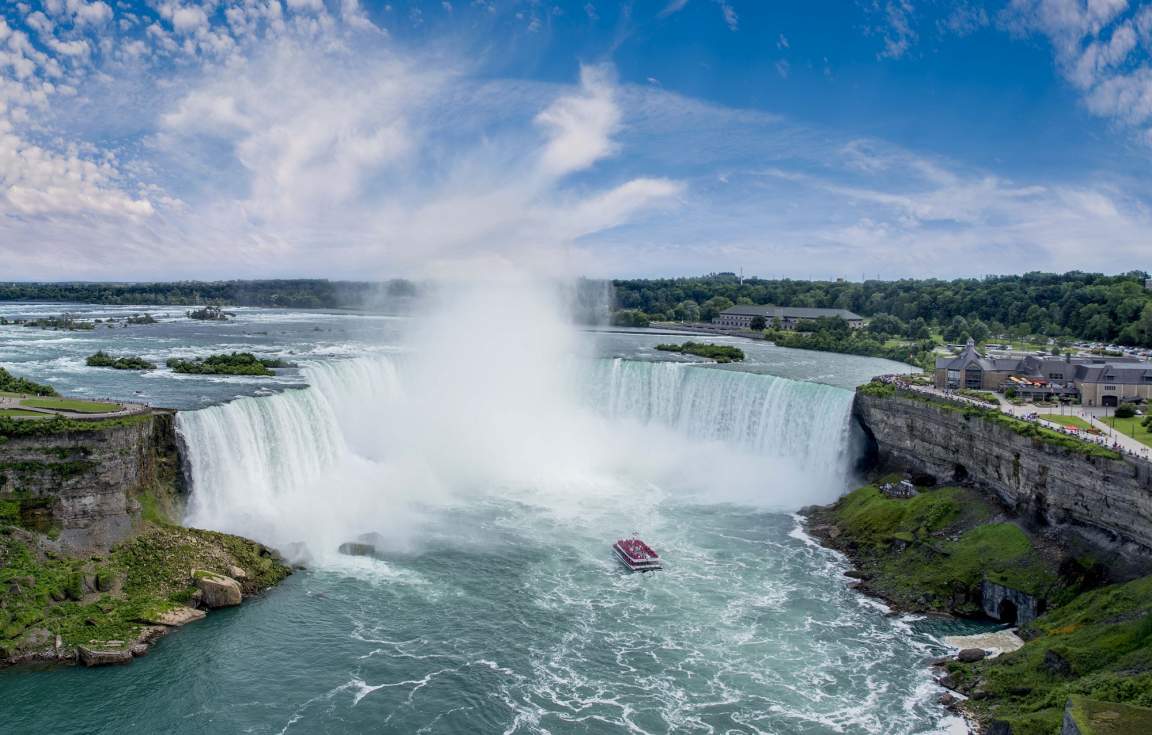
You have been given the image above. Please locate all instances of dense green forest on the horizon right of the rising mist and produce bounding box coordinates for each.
[613,271,1152,347]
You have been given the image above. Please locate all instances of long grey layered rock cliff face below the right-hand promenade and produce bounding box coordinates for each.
[852,392,1152,567]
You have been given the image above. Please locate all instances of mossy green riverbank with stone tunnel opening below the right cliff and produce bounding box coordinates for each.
[802,477,1152,735]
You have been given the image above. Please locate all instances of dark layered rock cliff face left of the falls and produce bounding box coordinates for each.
[0,411,182,554]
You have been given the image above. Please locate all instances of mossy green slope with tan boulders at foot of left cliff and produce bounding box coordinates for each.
[0,523,291,666]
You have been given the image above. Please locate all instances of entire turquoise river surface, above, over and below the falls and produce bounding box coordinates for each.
[0,306,949,734]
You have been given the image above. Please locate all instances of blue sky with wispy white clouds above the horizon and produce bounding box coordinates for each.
[0,0,1152,280]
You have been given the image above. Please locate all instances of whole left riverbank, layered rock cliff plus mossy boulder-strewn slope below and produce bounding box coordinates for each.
[0,387,290,666]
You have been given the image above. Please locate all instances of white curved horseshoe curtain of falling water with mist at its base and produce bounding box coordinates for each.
[179,357,851,557]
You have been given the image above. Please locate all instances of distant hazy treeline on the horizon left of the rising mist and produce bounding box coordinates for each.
[0,279,416,309]
